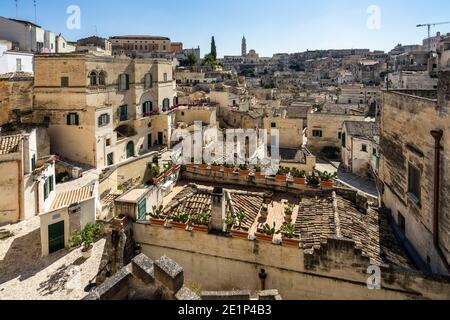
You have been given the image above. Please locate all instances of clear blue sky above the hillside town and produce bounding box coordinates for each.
[0,0,450,56]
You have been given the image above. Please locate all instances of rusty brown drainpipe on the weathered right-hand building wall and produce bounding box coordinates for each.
[430,130,450,273]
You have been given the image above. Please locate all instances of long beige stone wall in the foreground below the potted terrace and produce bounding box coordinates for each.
[133,223,450,300]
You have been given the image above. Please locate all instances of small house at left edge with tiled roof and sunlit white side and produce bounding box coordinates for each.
[0,127,56,225]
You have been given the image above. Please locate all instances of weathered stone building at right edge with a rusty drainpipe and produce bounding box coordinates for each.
[380,71,450,274]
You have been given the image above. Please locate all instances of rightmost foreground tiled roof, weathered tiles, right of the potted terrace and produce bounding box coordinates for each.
[295,192,414,269]
